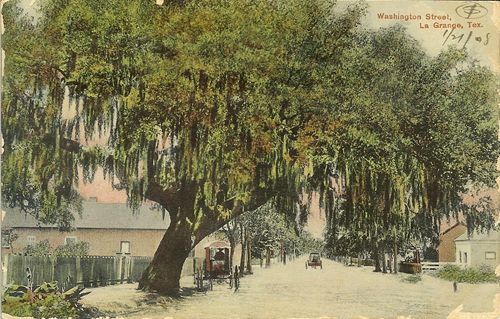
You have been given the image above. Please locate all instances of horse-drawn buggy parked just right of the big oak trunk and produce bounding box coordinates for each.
[194,241,239,290]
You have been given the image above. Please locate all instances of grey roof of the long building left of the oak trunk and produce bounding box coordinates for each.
[2,201,170,230]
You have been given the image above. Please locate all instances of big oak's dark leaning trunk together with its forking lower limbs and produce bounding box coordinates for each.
[139,180,272,295]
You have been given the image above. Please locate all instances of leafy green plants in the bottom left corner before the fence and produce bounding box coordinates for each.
[2,282,88,318]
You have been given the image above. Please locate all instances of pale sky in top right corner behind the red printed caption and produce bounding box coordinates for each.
[362,1,500,73]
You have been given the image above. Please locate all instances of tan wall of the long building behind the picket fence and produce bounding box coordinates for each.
[2,228,165,256]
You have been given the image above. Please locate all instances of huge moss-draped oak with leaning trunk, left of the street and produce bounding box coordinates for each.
[2,0,363,293]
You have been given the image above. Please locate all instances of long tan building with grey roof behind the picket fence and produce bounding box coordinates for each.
[2,200,170,256]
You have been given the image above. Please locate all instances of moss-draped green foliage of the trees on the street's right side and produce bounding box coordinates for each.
[320,27,500,255]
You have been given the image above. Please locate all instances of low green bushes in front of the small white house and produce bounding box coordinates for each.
[436,265,500,284]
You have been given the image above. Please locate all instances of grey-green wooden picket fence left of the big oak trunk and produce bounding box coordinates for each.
[2,254,151,288]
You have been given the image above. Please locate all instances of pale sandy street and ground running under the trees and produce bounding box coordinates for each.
[80,259,500,319]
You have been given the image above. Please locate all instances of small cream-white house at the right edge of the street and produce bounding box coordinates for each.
[455,230,500,269]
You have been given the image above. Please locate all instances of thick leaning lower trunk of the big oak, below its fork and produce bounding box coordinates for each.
[139,222,192,295]
